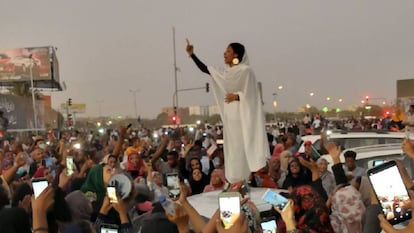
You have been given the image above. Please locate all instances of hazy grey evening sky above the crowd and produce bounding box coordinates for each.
[0,0,414,118]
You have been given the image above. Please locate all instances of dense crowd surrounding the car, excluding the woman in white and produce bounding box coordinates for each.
[0,121,414,232]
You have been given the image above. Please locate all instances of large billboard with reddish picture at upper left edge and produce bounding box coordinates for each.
[0,46,60,89]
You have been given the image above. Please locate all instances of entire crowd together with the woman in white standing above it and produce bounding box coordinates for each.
[0,36,414,233]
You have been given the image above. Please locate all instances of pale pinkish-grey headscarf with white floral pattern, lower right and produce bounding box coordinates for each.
[331,185,365,233]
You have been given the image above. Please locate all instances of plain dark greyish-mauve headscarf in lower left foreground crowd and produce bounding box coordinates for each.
[65,190,93,221]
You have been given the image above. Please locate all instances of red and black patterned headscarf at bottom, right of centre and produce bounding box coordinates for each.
[291,185,334,233]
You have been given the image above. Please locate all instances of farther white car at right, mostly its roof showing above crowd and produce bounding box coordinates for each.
[298,131,405,153]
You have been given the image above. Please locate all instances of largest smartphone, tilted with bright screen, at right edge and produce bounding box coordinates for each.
[368,161,411,225]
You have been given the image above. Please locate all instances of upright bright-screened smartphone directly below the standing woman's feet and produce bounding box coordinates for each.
[219,192,240,229]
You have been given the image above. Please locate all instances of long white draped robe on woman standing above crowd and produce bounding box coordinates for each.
[208,64,270,182]
